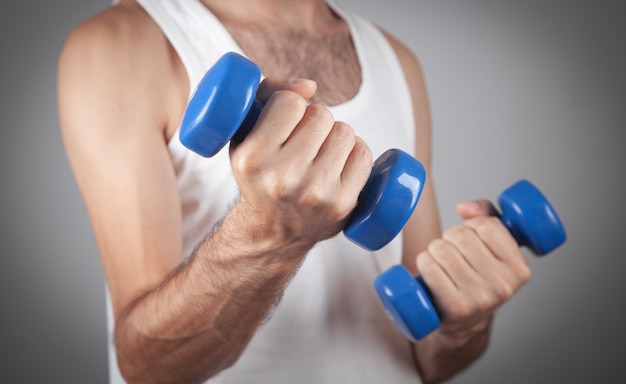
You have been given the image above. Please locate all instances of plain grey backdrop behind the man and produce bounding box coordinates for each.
[0,0,626,383]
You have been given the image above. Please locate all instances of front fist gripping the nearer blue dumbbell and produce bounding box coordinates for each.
[225,79,372,249]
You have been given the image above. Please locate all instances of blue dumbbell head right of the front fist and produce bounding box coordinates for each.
[344,148,426,251]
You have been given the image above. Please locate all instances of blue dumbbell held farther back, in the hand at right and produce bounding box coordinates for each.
[374,180,566,342]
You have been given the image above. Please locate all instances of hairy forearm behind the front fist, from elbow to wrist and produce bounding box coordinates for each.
[115,202,308,383]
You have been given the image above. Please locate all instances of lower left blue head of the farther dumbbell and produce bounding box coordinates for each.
[374,265,439,342]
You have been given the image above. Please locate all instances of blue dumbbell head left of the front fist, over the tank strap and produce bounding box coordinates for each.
[180,52,261,157]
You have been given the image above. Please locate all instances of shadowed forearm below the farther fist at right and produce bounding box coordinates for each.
[413,317,492,383]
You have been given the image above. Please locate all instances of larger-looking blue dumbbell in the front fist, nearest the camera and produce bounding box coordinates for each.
[180,52,426,251]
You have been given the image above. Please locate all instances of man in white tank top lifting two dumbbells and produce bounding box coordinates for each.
[59,0,529,383]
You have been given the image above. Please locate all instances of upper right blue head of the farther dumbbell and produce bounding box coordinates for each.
[498,180,567,255]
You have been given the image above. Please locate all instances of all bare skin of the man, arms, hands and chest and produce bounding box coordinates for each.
[58,0,530,383]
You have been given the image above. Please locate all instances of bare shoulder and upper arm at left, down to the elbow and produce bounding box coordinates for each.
[58,1,187,311]
